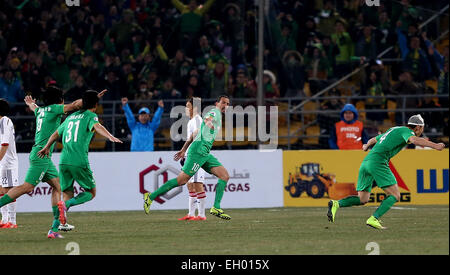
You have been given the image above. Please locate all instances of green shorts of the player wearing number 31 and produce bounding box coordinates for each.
[59,164,95,192]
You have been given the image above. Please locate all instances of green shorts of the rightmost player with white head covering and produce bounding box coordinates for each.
[356,160,397,192]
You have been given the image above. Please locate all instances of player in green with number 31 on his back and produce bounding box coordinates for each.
[37,90,122,229]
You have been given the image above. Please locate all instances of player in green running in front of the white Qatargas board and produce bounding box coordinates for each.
[144,95,231,220]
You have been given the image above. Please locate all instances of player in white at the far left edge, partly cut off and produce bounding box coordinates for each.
[0,99,19,228]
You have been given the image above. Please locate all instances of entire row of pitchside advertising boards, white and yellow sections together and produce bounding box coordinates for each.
[14,149,449,212]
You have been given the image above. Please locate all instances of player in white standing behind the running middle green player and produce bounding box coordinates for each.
[179,97,206,221]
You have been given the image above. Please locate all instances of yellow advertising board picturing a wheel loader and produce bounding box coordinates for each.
[283,149,449,206]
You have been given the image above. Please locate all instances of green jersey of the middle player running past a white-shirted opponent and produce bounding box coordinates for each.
[188,108,222,155]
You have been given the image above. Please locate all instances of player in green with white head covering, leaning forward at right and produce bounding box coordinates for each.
[327,115,445,229]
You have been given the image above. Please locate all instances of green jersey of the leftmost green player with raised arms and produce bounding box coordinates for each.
[33,104,64,157]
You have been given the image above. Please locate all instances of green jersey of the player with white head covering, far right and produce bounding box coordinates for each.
[365,126,415,163]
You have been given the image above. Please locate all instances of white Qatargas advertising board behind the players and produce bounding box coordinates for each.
[17,150,283,212]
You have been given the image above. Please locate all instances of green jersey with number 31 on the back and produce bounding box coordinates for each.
[58,110,98,168]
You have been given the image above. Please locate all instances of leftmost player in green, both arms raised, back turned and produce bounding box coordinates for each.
[0,86,89,239]
